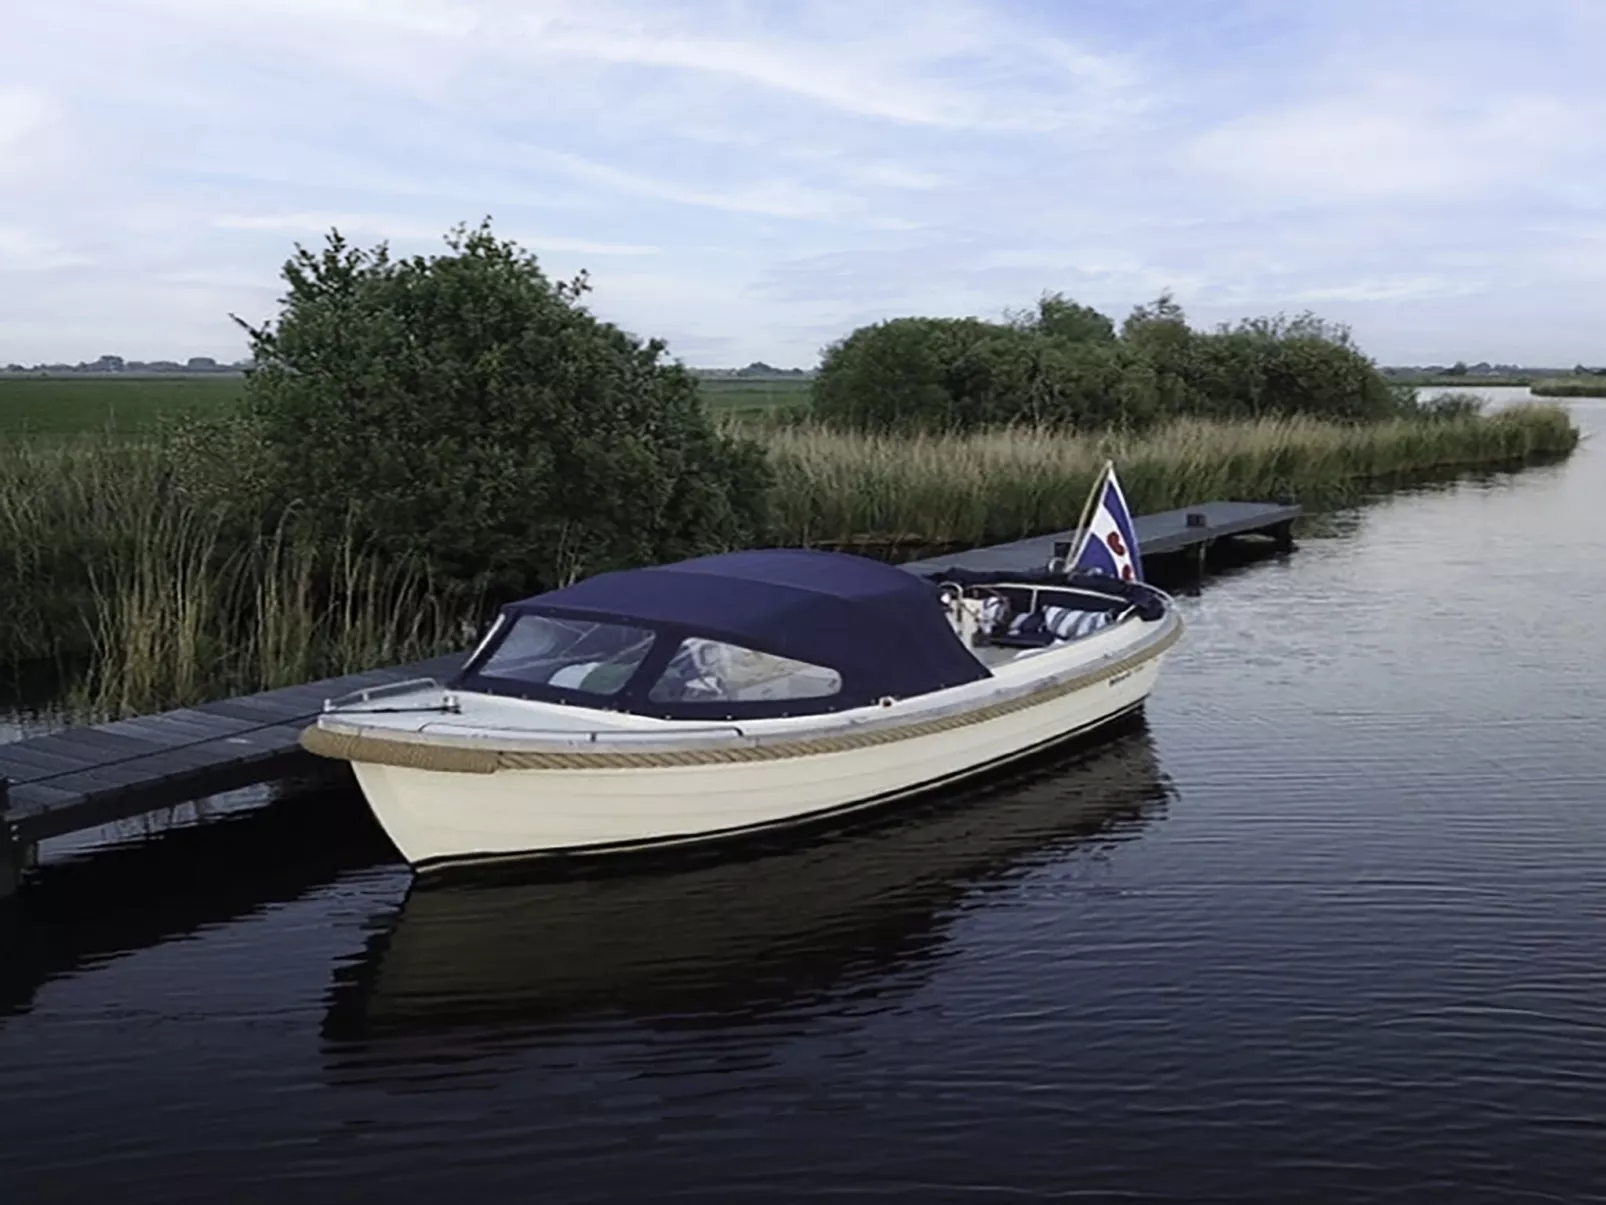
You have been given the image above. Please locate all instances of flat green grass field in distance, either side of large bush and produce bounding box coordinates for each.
[0,376,809,437]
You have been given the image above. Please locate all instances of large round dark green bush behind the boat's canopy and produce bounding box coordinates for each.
[236,220,769,596]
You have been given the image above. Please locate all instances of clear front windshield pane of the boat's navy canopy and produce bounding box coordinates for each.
[479,615,654,696]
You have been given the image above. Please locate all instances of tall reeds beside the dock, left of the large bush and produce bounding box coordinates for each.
[0,437,477,718]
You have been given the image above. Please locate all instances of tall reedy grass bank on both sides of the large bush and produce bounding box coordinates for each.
[0,405,1577,717]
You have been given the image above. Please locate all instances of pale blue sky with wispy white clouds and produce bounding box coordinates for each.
[0,0,1606,368]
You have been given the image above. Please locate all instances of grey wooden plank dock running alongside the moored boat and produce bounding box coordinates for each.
[0,501,1299,898]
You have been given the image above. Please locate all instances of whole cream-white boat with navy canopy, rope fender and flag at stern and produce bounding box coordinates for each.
[300,464,1182,872]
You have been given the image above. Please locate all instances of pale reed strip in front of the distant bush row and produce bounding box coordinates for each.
[761,405,1579,546]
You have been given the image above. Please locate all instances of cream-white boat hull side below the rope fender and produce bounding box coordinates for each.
[353,652,1161,871]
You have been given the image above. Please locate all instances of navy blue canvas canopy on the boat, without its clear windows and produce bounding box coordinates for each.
[453,548,988,717]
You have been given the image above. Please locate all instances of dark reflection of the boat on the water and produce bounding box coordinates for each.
[324,718,1171,1062]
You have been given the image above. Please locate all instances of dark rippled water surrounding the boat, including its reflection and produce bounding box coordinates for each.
[0,402,1606,1205]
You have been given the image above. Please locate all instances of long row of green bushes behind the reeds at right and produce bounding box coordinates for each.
[814,294,1415,432]
